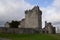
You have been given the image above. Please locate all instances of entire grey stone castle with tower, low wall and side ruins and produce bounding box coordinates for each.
[0,6,56,34]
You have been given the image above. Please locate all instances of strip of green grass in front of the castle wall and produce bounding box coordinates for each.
[0,34,60,40]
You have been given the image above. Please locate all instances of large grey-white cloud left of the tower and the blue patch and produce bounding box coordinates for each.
[0,0,33,26]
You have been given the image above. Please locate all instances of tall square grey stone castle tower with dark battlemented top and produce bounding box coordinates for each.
[25,6,42,29]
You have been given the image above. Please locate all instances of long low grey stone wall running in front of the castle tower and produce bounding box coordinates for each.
[0,28,38,34]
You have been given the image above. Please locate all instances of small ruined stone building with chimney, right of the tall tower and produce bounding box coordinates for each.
[43,21,56,34]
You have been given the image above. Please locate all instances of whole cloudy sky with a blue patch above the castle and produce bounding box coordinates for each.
[0,0,60,32]
